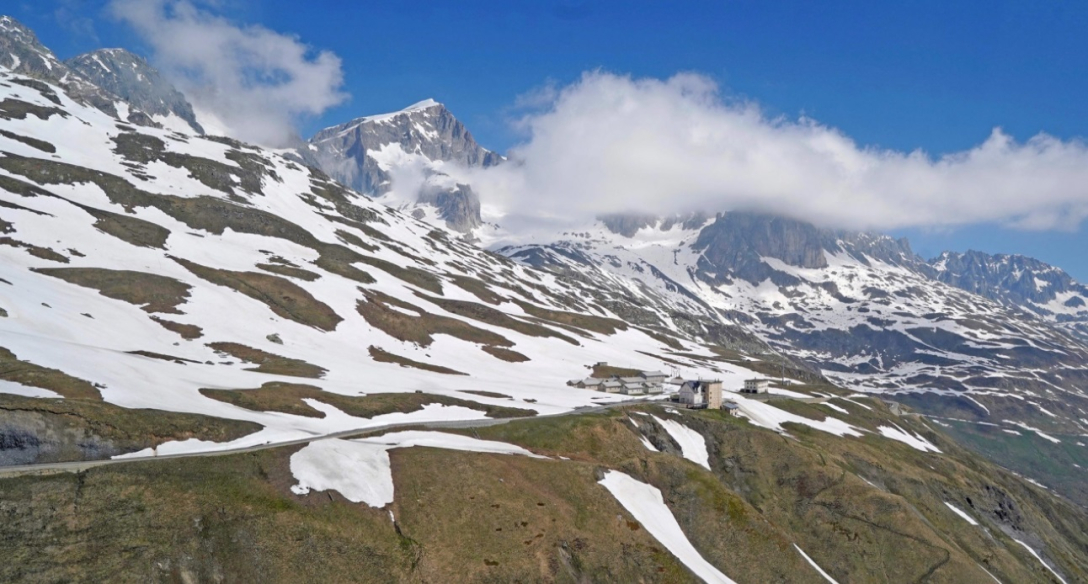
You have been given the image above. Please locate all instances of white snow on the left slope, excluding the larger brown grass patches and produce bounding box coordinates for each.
[0,71,753,456]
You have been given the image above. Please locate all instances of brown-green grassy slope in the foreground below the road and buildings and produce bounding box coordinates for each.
[0,406,1088,583]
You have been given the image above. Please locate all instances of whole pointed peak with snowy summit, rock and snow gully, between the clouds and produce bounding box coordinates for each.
[300,99,502,233]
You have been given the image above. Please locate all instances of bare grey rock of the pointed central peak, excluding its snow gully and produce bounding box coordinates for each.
[300,100,503,232]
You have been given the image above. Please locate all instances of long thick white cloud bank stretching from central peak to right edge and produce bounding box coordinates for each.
[472,72,1088,229]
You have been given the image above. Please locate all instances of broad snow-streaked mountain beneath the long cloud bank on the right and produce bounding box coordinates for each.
[502,213,1088,433]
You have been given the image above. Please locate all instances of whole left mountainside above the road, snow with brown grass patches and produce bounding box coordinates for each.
[0,63,787,452]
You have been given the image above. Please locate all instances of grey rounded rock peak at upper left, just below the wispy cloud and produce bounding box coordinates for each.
[64,49,203,134]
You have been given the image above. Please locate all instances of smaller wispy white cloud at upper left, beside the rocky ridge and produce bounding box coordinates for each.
[109,0,347,146]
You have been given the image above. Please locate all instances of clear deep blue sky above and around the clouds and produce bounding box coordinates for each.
[5,0,1088,281]
